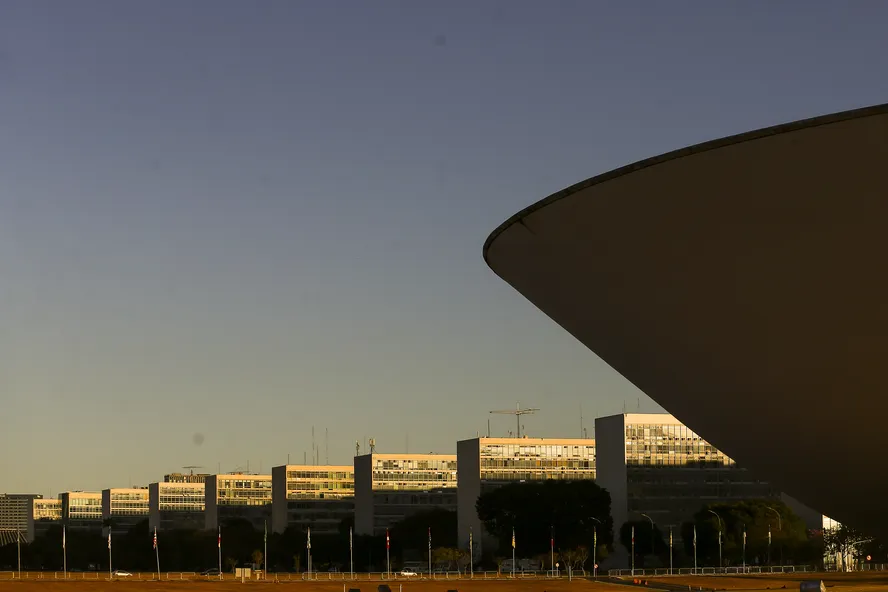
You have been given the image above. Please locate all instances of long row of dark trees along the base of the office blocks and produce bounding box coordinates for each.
[0,480,888,572]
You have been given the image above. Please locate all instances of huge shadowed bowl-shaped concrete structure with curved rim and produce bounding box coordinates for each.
[484,105,888,535]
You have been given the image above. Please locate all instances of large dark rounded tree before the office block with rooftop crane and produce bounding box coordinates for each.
[475,480,613,557]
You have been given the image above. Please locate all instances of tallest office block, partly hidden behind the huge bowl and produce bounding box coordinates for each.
[595,413,781,539]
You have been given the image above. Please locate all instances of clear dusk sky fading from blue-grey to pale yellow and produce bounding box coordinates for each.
[0,0,888,495]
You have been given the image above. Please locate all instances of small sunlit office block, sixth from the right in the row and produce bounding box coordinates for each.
[148,481,206,530]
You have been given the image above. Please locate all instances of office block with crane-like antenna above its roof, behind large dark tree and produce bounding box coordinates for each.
[456,437,596,555]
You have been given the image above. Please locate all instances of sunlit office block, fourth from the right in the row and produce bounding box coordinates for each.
[271,465,355,534]
